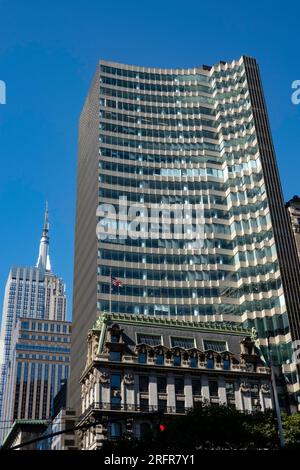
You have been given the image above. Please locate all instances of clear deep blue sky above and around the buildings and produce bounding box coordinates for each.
[0,0,300,322]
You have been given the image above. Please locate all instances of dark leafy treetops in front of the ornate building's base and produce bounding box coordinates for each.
[104,403,300,453]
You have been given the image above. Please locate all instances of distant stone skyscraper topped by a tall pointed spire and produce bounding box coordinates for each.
[0,208,67,440]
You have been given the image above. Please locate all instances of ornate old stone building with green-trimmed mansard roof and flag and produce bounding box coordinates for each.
[78,314,272,450]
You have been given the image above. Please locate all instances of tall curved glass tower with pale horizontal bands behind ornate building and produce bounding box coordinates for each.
[70,57,300,414]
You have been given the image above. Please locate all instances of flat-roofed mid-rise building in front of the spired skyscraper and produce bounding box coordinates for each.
[1,318,71,437]
